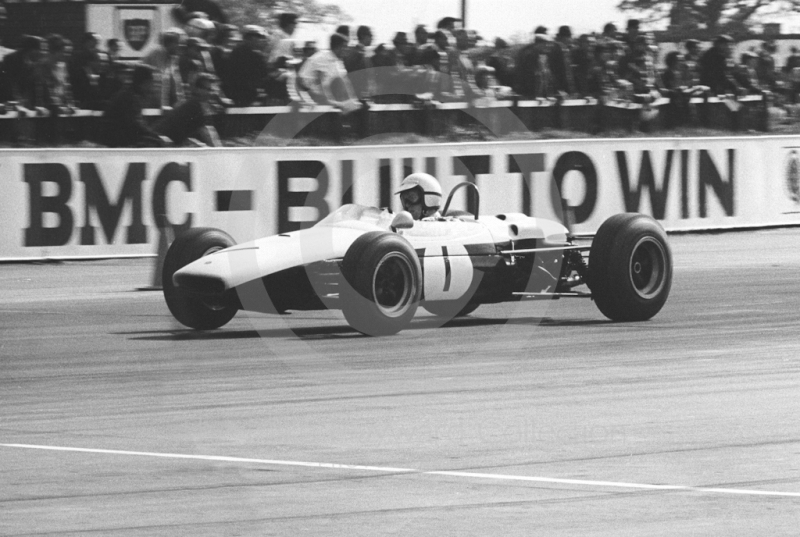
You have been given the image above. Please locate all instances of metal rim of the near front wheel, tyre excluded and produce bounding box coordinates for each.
[372,252,414,317]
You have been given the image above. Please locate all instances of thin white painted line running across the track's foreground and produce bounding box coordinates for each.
[0,444,800,498]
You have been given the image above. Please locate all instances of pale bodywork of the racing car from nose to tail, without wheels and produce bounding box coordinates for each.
[173,205,567,311]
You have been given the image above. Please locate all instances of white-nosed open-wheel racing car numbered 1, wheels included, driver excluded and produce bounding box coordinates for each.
[163,182,672,336]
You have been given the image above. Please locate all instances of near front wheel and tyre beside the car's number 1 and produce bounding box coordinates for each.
[339,231,422,336]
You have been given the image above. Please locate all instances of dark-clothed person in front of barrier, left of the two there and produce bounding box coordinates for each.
[103,64,169,147]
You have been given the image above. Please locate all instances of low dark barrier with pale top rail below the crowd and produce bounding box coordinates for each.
[0,95,769,145]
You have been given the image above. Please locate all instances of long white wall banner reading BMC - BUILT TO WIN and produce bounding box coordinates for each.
[0,137,800,259]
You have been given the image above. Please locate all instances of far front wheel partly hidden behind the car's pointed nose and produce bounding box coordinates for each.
[162,227,238,330]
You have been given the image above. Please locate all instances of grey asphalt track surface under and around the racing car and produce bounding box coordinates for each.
[0,229,800,536]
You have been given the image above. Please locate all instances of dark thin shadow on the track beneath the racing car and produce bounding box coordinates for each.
[113,317,613,341]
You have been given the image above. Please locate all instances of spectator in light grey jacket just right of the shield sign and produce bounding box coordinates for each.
[142,28,186,108]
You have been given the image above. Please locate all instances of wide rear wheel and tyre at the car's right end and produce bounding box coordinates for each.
[589,213,672,321]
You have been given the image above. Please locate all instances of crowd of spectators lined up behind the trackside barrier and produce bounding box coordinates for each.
[0,5,800,145]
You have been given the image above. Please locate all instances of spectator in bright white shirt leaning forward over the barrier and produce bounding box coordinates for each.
[298,33,360,113]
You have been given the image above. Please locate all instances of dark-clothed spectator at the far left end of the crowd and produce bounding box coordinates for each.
[2,35,47,109]
